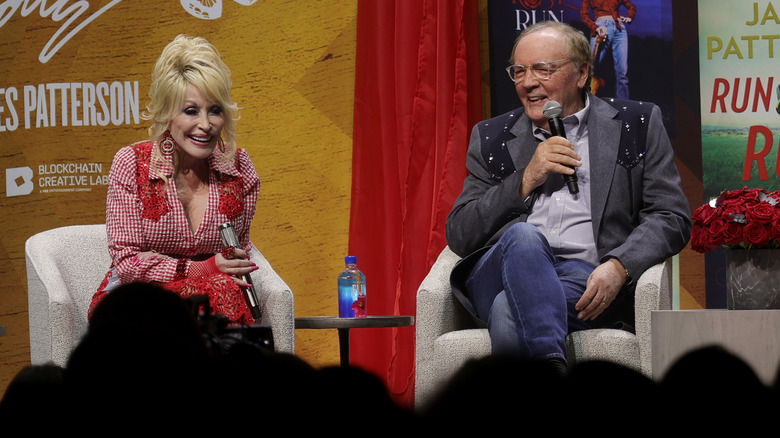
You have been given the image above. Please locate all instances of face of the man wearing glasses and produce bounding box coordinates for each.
[513,29,588,128]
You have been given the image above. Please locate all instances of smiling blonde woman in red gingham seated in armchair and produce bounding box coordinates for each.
[89,35,260,324]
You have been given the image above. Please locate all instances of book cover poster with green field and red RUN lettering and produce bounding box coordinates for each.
[698,0,780,202]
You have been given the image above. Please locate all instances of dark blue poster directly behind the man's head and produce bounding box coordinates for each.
[488,0,674,136]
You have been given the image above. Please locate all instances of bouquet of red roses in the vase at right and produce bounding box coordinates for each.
[691,188,780,253]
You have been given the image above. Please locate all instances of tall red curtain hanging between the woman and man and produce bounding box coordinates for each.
[349,0,482,406]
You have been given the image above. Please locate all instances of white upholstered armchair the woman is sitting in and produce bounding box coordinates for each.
[25,224,295,366]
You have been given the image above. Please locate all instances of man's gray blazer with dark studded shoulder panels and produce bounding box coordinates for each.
[447,94,691,318]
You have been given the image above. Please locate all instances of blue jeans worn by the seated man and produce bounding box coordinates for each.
[466,222,595,360]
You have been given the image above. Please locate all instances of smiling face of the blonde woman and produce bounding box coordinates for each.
[169,85,225,159]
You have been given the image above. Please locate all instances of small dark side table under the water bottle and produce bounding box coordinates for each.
[295,315,414,366]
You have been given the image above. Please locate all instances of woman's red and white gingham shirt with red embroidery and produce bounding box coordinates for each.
[106,142,260,283]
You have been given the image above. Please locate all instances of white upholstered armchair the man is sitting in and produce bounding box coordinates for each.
[415,247,672,407]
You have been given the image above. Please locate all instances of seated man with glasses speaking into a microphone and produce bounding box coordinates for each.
[447,21,691,372]
